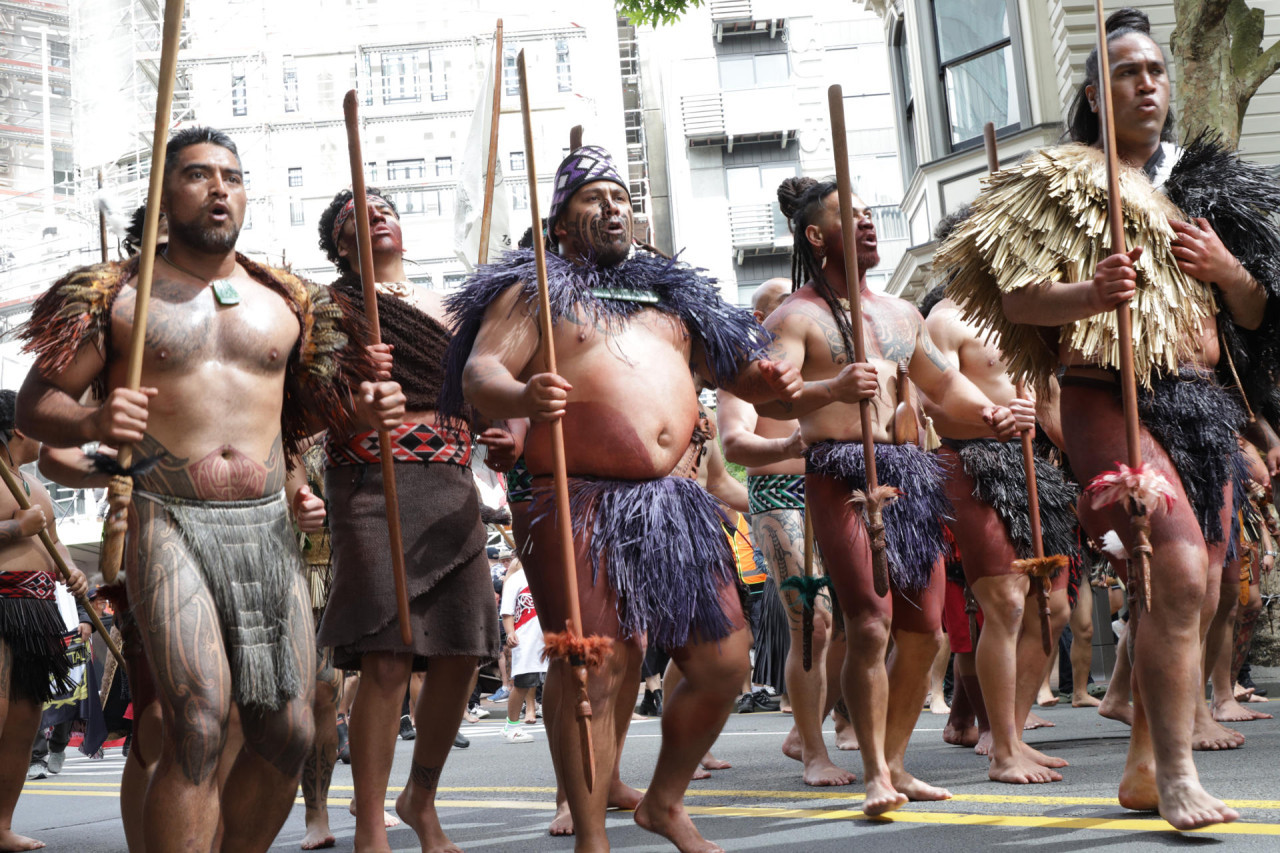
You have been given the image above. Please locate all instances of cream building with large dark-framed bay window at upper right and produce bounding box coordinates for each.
[863,0,1280,300]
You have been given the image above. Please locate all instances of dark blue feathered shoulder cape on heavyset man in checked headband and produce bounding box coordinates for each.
[436,248,769,418]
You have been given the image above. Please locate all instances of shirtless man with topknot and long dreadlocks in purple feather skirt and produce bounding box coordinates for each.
[756,171,1023,815]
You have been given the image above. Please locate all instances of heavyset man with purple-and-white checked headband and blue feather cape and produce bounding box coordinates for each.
[440,146,800,850]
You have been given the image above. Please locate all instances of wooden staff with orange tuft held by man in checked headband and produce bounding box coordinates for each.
[516,50,613,792]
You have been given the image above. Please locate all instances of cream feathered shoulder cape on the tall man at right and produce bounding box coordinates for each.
[934,143,1215,388]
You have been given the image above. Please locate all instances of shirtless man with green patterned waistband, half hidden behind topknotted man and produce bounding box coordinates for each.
[716,278,854,786]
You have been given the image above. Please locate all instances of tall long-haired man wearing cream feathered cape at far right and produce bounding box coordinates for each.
[937,9,1280,829]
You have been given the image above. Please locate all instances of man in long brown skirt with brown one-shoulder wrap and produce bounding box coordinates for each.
[320,190,499,850]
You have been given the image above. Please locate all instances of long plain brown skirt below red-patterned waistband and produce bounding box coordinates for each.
[320,462,498,670]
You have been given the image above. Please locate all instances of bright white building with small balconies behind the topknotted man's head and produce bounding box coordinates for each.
[639,0,908,304]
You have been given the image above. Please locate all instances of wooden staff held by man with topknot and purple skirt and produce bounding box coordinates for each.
[827,83,899,598]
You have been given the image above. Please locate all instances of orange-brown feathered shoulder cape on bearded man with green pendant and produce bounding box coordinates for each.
[19,255,376,464]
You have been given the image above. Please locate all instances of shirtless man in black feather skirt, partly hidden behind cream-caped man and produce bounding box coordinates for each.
[924,275,1079,784]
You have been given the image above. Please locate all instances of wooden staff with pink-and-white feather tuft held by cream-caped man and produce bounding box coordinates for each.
[1085,0,1175,611]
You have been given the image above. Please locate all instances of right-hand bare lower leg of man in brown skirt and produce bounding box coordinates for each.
[391,657,476,853]
